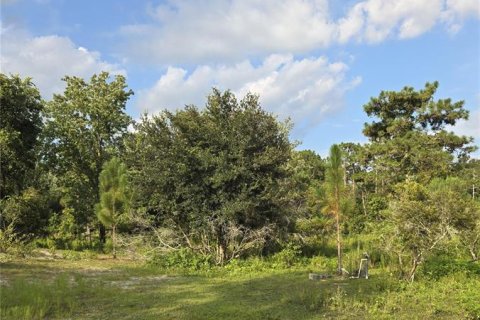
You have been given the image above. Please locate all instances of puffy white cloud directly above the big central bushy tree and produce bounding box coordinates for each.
[138,55,361,129]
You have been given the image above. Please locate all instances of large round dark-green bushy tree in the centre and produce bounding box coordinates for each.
[126,90,292,264]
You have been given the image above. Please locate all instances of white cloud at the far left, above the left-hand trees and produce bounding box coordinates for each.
[0,26,125,99]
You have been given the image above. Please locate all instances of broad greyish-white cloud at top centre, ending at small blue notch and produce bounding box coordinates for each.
[121,0,335,64]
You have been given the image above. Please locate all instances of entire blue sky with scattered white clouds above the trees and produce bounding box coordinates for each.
[0,0,480,155]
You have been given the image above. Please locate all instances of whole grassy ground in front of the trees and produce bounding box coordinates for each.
[0,252,480,320]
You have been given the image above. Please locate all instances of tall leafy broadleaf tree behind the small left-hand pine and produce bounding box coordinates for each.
[43,72,133,241]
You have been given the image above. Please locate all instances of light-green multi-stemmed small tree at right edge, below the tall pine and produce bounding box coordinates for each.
[389,178,480,281]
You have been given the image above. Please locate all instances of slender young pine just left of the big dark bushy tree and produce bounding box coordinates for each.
[97,157,129,259]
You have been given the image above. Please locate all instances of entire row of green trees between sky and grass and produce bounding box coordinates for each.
[0,73,480,278]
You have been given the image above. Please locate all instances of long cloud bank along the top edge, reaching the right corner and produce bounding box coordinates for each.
[121,0,480,65]
